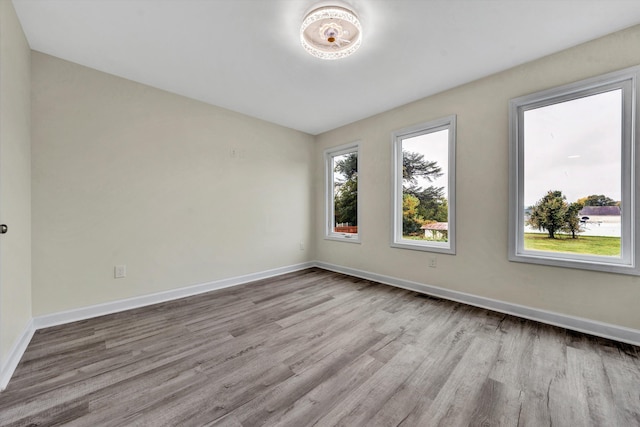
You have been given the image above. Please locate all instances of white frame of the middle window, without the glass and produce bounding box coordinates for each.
[391,114,456,254]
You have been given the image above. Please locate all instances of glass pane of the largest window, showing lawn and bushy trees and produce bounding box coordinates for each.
[522,89,625,258]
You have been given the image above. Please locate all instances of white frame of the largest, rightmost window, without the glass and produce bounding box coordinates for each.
[509,67,640,275]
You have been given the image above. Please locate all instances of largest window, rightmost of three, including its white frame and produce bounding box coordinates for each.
[509,69,640,275]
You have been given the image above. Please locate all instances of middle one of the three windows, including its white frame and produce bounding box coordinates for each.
[391,116,456,254]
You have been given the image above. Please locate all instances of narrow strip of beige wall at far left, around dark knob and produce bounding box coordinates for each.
[0,1,31,366]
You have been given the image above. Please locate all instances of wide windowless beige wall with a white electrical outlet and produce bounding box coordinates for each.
[32,52,314,316]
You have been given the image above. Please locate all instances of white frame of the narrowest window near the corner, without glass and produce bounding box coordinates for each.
[324,141,361,243]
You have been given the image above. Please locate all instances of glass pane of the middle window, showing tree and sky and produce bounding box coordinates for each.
[401,129,449,242]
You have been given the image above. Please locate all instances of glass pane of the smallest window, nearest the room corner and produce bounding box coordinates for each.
[331,152,358,234]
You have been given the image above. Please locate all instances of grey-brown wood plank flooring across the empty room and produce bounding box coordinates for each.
[0,269,640,427]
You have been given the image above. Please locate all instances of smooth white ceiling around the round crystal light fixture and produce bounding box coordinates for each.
[11,0,640,134]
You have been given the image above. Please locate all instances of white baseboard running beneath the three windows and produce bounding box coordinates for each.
[315,262,640,346]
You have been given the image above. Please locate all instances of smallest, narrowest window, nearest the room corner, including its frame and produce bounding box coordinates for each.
[325,143,360,242]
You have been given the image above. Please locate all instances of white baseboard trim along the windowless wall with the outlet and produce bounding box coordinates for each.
[33,262,315,329]
